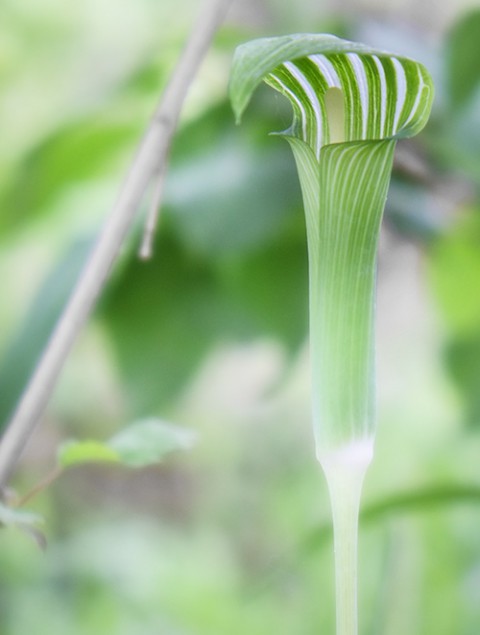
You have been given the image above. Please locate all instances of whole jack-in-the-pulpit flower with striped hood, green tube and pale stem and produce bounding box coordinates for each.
[230,34,433,635]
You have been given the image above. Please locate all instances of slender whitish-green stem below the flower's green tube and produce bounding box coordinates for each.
[318,440,373,635]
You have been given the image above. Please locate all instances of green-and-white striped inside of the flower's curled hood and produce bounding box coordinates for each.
[266,53,429,158]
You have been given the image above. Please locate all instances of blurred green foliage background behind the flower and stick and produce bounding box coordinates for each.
[0,0,480,635]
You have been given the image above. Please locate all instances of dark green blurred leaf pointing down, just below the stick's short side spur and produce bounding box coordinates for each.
[100,231,225,413]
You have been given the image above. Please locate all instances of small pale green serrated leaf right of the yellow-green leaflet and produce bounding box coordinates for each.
[108,419,197,467]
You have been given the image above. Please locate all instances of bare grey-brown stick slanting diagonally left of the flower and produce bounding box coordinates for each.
[0,0,232,492]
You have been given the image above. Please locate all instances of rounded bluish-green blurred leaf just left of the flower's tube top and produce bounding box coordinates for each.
[165,135,299,257]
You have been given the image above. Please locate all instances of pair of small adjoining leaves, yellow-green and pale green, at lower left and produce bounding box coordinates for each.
[57,419,196,468]
